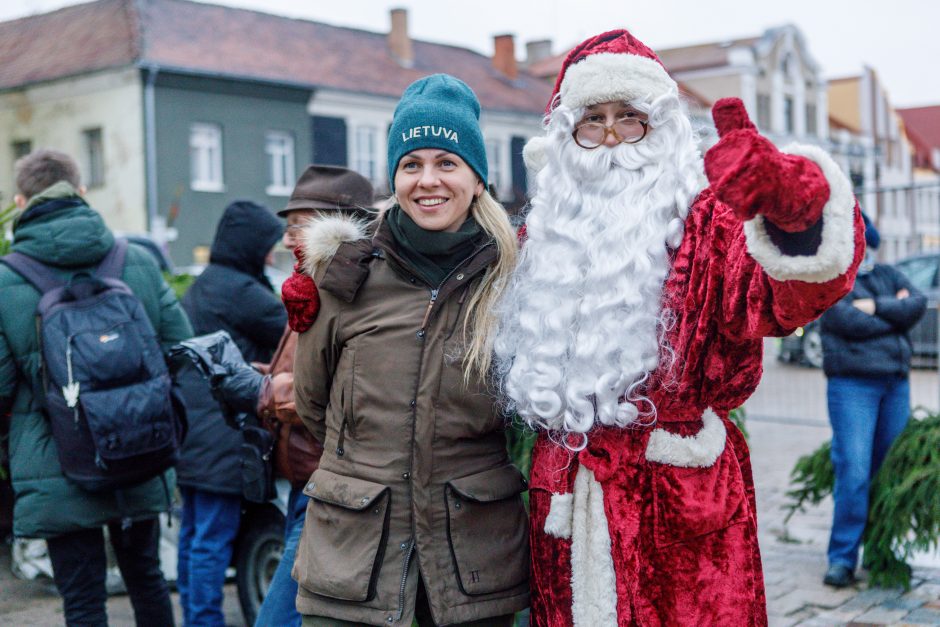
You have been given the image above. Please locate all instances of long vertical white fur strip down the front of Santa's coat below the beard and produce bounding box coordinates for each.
[571,466,617,627]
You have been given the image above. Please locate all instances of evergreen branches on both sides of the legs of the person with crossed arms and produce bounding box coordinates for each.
[786,410,940,589]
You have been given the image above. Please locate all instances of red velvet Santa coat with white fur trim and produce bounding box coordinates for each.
[530,147,864,627]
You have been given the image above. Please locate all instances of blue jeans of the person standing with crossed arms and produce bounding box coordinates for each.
[827,376,911,570]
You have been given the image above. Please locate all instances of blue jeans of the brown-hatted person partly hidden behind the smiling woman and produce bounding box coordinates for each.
[255,488,309,627]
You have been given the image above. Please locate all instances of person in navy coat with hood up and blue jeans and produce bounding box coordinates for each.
[177,201,287,626]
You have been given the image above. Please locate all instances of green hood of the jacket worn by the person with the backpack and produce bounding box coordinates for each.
[12,181,114,268]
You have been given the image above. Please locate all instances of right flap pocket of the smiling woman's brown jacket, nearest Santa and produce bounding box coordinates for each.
[445,465,529,595]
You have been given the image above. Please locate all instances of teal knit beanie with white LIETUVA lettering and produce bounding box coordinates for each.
[388,74,489,192]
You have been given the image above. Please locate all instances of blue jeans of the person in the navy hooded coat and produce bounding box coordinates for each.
[176,486,242,627]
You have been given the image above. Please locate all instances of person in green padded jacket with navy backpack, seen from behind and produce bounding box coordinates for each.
[0,150,192,627]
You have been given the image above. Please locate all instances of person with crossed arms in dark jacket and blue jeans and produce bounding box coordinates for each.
[821,217,927,587]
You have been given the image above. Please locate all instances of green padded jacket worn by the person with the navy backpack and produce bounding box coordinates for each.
[0,182,192,538]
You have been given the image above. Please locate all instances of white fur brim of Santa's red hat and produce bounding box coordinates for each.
[558,52,679,109]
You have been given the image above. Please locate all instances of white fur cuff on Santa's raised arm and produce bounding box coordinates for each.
[744,144,855,283]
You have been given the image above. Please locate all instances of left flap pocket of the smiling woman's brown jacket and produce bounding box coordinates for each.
[291,468,390,602]
